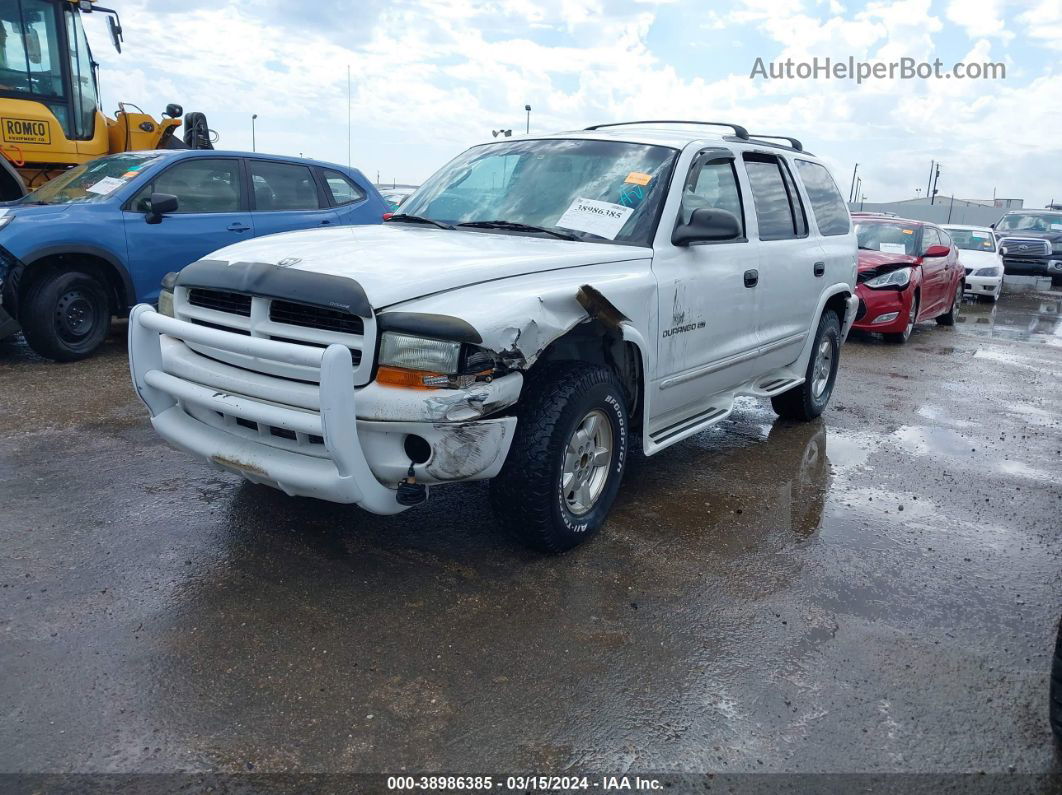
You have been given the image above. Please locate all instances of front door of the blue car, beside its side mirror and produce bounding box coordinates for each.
[122,157,254,303]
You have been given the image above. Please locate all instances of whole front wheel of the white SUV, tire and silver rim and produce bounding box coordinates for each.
[491,364,629,552]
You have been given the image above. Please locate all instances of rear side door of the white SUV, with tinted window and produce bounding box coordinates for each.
[742,152,825,371]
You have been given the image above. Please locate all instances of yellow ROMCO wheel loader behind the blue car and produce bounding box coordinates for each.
[0,0,213,201]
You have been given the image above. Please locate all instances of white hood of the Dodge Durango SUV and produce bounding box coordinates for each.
[203,223,652,309]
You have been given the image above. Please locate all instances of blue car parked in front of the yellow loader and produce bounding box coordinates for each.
[0,150,389,361]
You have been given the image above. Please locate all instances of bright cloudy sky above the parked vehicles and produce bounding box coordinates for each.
[86,0,1062,207]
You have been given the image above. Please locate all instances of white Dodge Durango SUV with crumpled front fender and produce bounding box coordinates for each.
[130,122,858,552]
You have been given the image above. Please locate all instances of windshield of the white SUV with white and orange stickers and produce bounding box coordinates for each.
[399,140,678,245]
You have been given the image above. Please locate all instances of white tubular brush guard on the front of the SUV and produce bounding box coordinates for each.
[130,304,406,514]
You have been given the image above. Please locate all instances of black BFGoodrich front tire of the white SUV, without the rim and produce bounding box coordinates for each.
[491,363,630,553]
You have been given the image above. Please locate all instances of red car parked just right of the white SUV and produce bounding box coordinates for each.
[852,213,965,343]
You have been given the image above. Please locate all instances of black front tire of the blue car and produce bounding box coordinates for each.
[18,271,112,362]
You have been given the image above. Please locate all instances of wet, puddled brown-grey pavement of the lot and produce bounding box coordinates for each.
[0,294,1062,774]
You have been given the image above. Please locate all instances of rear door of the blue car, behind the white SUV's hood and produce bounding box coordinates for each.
[247,158,339,237]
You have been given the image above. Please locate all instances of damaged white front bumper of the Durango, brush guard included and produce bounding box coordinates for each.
[130,305,523,514]
